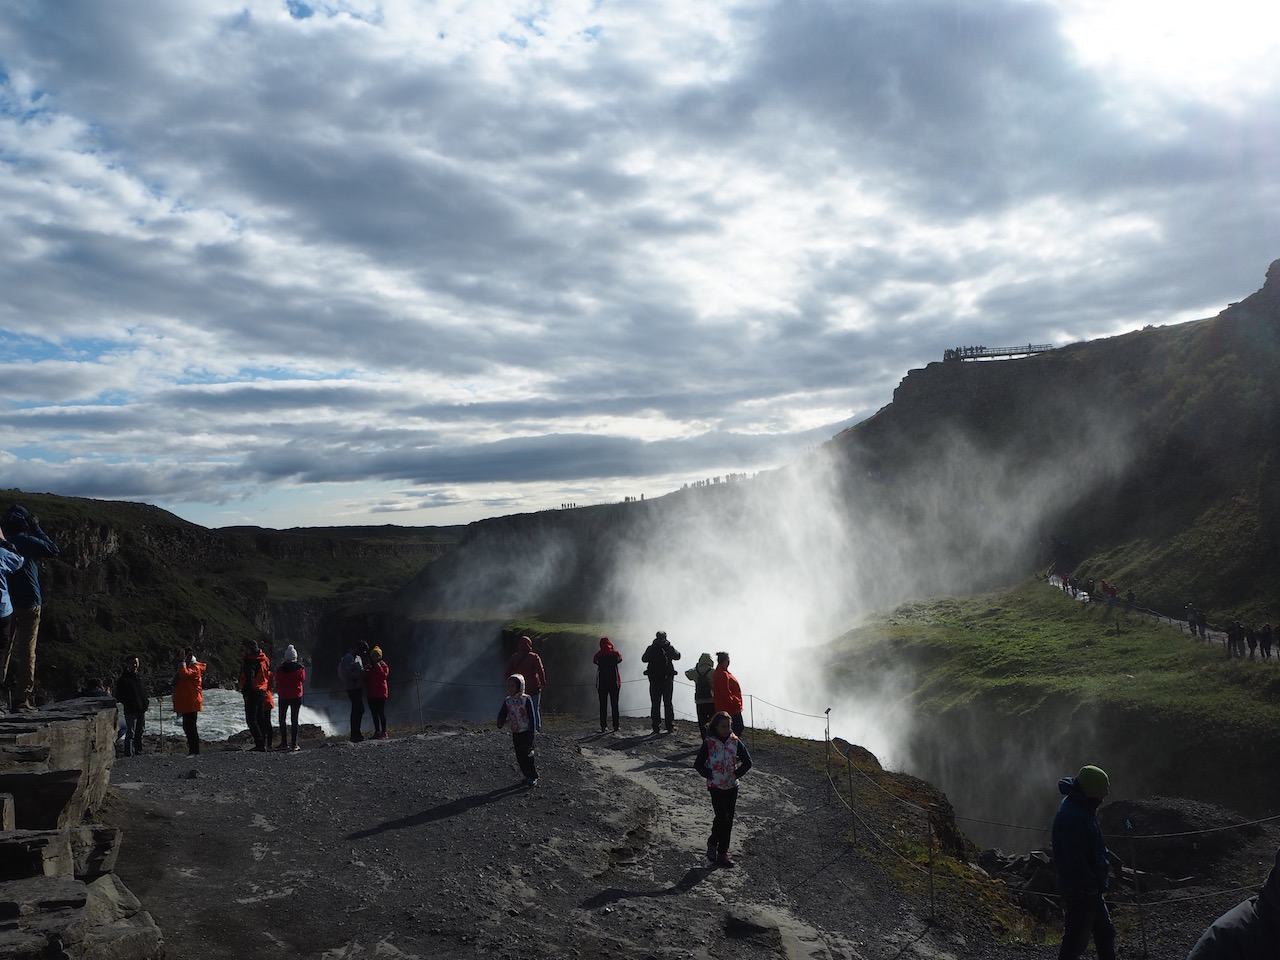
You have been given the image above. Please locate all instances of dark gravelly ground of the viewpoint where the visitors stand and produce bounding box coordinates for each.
[106,718,1276,960]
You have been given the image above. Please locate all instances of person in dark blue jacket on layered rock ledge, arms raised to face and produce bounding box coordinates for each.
[0,504,59,713]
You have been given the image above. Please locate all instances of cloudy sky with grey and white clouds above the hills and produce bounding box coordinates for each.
[0,0,1280,526]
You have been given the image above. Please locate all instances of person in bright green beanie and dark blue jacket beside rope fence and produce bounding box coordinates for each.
[1053,765,1116,960]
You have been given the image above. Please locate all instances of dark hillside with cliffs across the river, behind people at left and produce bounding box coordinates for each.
[0,490,454,699]
